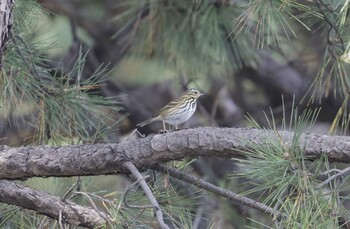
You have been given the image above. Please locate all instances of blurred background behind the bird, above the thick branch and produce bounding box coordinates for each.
[31,0,343,138]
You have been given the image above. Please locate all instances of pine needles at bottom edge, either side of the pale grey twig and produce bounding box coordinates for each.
[104,174,200,228]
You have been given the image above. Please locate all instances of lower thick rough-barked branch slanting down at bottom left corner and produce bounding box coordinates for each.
[0,180,109,228]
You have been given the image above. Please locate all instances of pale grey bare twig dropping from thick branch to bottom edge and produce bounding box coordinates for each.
[123,161,170,229]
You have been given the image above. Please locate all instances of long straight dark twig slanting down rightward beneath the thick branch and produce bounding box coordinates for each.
[153,164,286,218]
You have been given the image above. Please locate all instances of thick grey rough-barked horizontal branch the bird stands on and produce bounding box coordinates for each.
[0,127,350,179]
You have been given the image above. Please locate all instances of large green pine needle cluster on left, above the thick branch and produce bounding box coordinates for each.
[0,1,120,144]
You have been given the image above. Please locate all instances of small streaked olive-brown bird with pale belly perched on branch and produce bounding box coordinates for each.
[137,89,203,131]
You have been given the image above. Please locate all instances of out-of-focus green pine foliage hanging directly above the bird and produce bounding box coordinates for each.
[114,0,255,78]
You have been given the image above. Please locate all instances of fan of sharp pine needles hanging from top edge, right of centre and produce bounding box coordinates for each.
[233,0,320,49]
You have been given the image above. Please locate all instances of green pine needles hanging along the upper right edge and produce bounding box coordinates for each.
[309,0,350,134]
